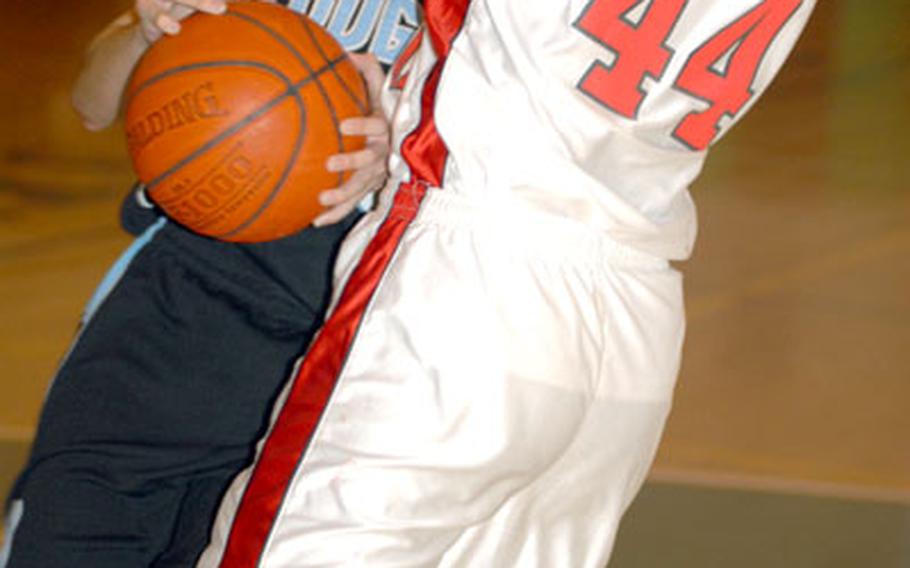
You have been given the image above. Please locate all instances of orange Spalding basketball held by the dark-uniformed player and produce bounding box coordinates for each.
[124,2,369,242]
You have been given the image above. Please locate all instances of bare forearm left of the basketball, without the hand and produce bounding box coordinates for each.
[72,12,149,130]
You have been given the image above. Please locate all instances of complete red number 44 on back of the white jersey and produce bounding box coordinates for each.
[575,0,803,150]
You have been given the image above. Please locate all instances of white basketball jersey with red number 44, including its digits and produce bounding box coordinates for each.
[387,0,814,260]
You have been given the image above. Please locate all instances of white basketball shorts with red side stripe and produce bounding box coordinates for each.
[201,184,684,568]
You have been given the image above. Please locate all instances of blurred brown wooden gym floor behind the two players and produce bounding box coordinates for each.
[0,0,910,568]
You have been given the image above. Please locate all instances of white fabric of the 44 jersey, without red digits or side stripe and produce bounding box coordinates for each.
[382,0,814,260]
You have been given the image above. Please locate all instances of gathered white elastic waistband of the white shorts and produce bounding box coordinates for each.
[415,187,670,270]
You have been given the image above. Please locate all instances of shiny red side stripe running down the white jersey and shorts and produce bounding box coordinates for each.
[215,0,470,568]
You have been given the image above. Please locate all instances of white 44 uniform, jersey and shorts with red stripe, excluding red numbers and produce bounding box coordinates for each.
[200,0,812,568]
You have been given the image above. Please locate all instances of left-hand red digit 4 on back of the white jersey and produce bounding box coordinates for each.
[575,0,686,118]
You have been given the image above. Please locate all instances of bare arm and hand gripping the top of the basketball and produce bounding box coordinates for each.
[72,0,226,130]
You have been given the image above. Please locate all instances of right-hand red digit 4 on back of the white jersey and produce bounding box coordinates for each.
[673,0,801,150]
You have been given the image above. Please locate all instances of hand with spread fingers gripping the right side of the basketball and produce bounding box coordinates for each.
[313,53,390,227]
